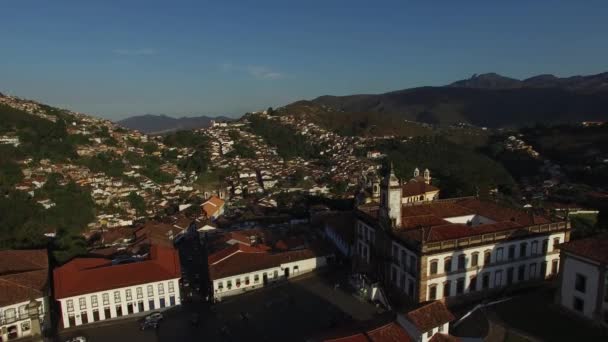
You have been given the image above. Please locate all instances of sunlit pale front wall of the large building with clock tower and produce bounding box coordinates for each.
[425,232,565,300]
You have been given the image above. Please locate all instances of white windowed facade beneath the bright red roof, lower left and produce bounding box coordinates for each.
[57,278,181,328]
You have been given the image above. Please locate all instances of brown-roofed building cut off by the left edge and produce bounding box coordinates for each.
[0,249,49,341]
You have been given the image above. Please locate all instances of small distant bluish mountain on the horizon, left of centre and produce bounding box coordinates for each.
[117,114,233,134]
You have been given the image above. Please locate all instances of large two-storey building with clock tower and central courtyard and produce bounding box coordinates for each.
[356,166,570,302]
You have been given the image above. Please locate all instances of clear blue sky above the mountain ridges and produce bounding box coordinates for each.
[0,0,608,120]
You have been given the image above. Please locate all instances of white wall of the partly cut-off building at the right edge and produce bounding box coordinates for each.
[560,254,605,318]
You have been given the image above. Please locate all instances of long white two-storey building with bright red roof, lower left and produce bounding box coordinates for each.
[53,245,181,328]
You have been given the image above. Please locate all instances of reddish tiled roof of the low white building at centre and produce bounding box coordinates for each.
[209,245,320,280]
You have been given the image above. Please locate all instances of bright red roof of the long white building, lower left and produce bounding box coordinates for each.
[53,245,181,298]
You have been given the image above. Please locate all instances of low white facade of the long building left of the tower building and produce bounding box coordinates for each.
[213,256,327,299]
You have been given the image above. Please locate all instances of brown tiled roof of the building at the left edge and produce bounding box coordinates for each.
[0,249,49,306]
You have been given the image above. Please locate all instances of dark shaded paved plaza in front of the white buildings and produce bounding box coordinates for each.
[62,272,376,342]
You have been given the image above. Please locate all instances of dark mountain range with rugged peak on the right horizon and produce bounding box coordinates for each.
[278,73,608,131]
